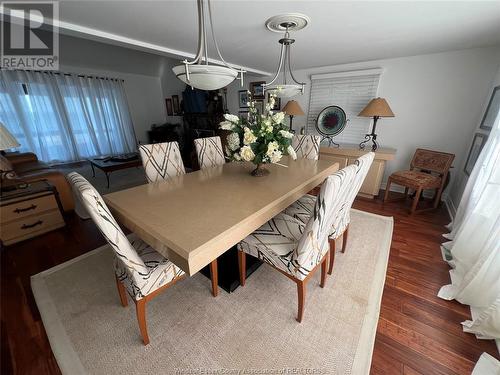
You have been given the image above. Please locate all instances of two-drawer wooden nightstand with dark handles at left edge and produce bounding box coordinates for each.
[0,181,65,245]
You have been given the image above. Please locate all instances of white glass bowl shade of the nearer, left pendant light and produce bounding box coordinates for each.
[172,64,238,90]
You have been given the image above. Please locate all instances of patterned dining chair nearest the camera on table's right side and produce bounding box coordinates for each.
[238,165,356,322]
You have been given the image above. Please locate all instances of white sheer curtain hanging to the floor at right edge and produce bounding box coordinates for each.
[438,113,500,339]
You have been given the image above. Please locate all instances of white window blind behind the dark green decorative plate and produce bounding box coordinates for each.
[307,69,382,144]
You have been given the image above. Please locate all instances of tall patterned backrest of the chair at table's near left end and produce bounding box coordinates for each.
[67,172,149,288]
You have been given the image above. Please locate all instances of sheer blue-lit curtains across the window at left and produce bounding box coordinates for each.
[0,70,136,162]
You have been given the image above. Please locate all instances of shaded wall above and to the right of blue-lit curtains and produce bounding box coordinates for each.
[60,35,169,143]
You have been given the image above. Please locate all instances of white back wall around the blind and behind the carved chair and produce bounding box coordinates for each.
[294,46,500,209]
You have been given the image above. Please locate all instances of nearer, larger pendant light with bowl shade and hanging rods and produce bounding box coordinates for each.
[172,0,245,90]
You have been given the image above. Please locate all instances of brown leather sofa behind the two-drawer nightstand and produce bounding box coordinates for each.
[0,152,75,211]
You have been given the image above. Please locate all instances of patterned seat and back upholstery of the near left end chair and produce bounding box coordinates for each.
[67,172,184,300]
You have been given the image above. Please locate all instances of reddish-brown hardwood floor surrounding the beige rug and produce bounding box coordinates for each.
[0,195,499,375]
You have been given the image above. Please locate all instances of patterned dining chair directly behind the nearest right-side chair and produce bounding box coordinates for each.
[283,152,375,275]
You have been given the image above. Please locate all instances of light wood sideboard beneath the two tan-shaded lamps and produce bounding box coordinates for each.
[319,145,396,199]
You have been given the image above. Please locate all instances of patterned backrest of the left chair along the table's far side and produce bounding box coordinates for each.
[139,142,186,182]
